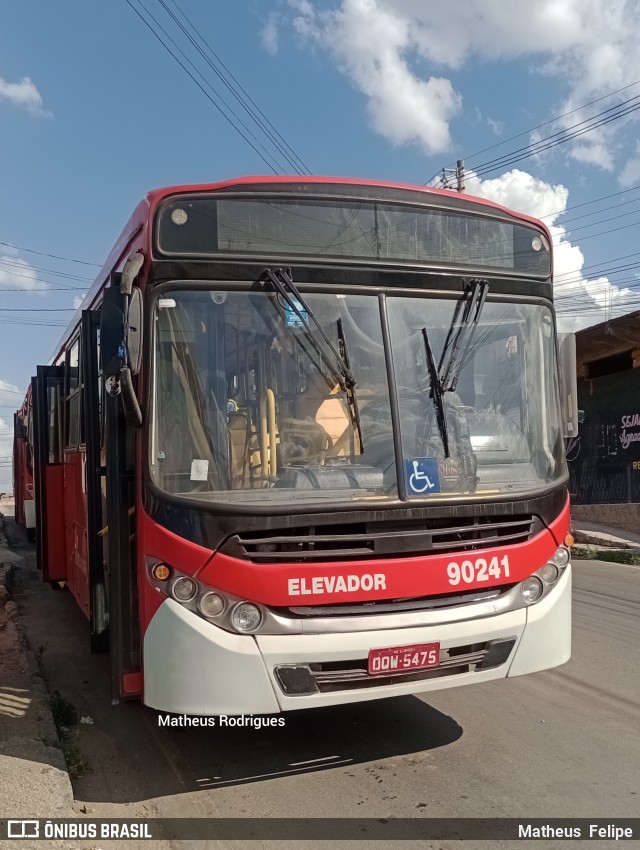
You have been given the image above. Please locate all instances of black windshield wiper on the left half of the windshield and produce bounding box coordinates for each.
[262,269,364,454]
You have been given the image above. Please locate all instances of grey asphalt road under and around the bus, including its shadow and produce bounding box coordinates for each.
[2,521,640,850]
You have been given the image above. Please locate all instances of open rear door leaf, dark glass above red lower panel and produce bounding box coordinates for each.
[32,366,67,582]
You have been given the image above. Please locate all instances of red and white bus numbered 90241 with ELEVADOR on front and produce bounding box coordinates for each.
[18,177,572,715]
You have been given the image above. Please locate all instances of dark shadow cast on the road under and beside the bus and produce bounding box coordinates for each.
[6,510,462,803]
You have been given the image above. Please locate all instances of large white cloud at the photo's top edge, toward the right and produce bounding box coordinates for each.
[288,0,640,164]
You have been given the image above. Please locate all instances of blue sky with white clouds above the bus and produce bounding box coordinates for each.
[0,0,640,492]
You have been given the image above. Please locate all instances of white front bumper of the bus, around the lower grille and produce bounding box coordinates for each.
[144,566,571,715]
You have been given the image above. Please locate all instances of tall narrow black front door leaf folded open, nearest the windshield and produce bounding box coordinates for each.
[80,310,109,652]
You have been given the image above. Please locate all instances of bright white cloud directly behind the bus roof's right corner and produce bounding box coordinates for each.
[465,169,637,331]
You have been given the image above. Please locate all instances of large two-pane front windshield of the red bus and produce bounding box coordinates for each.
[149,286,564,508]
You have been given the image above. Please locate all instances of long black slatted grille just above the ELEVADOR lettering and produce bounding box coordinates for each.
[220,515,542,564]
